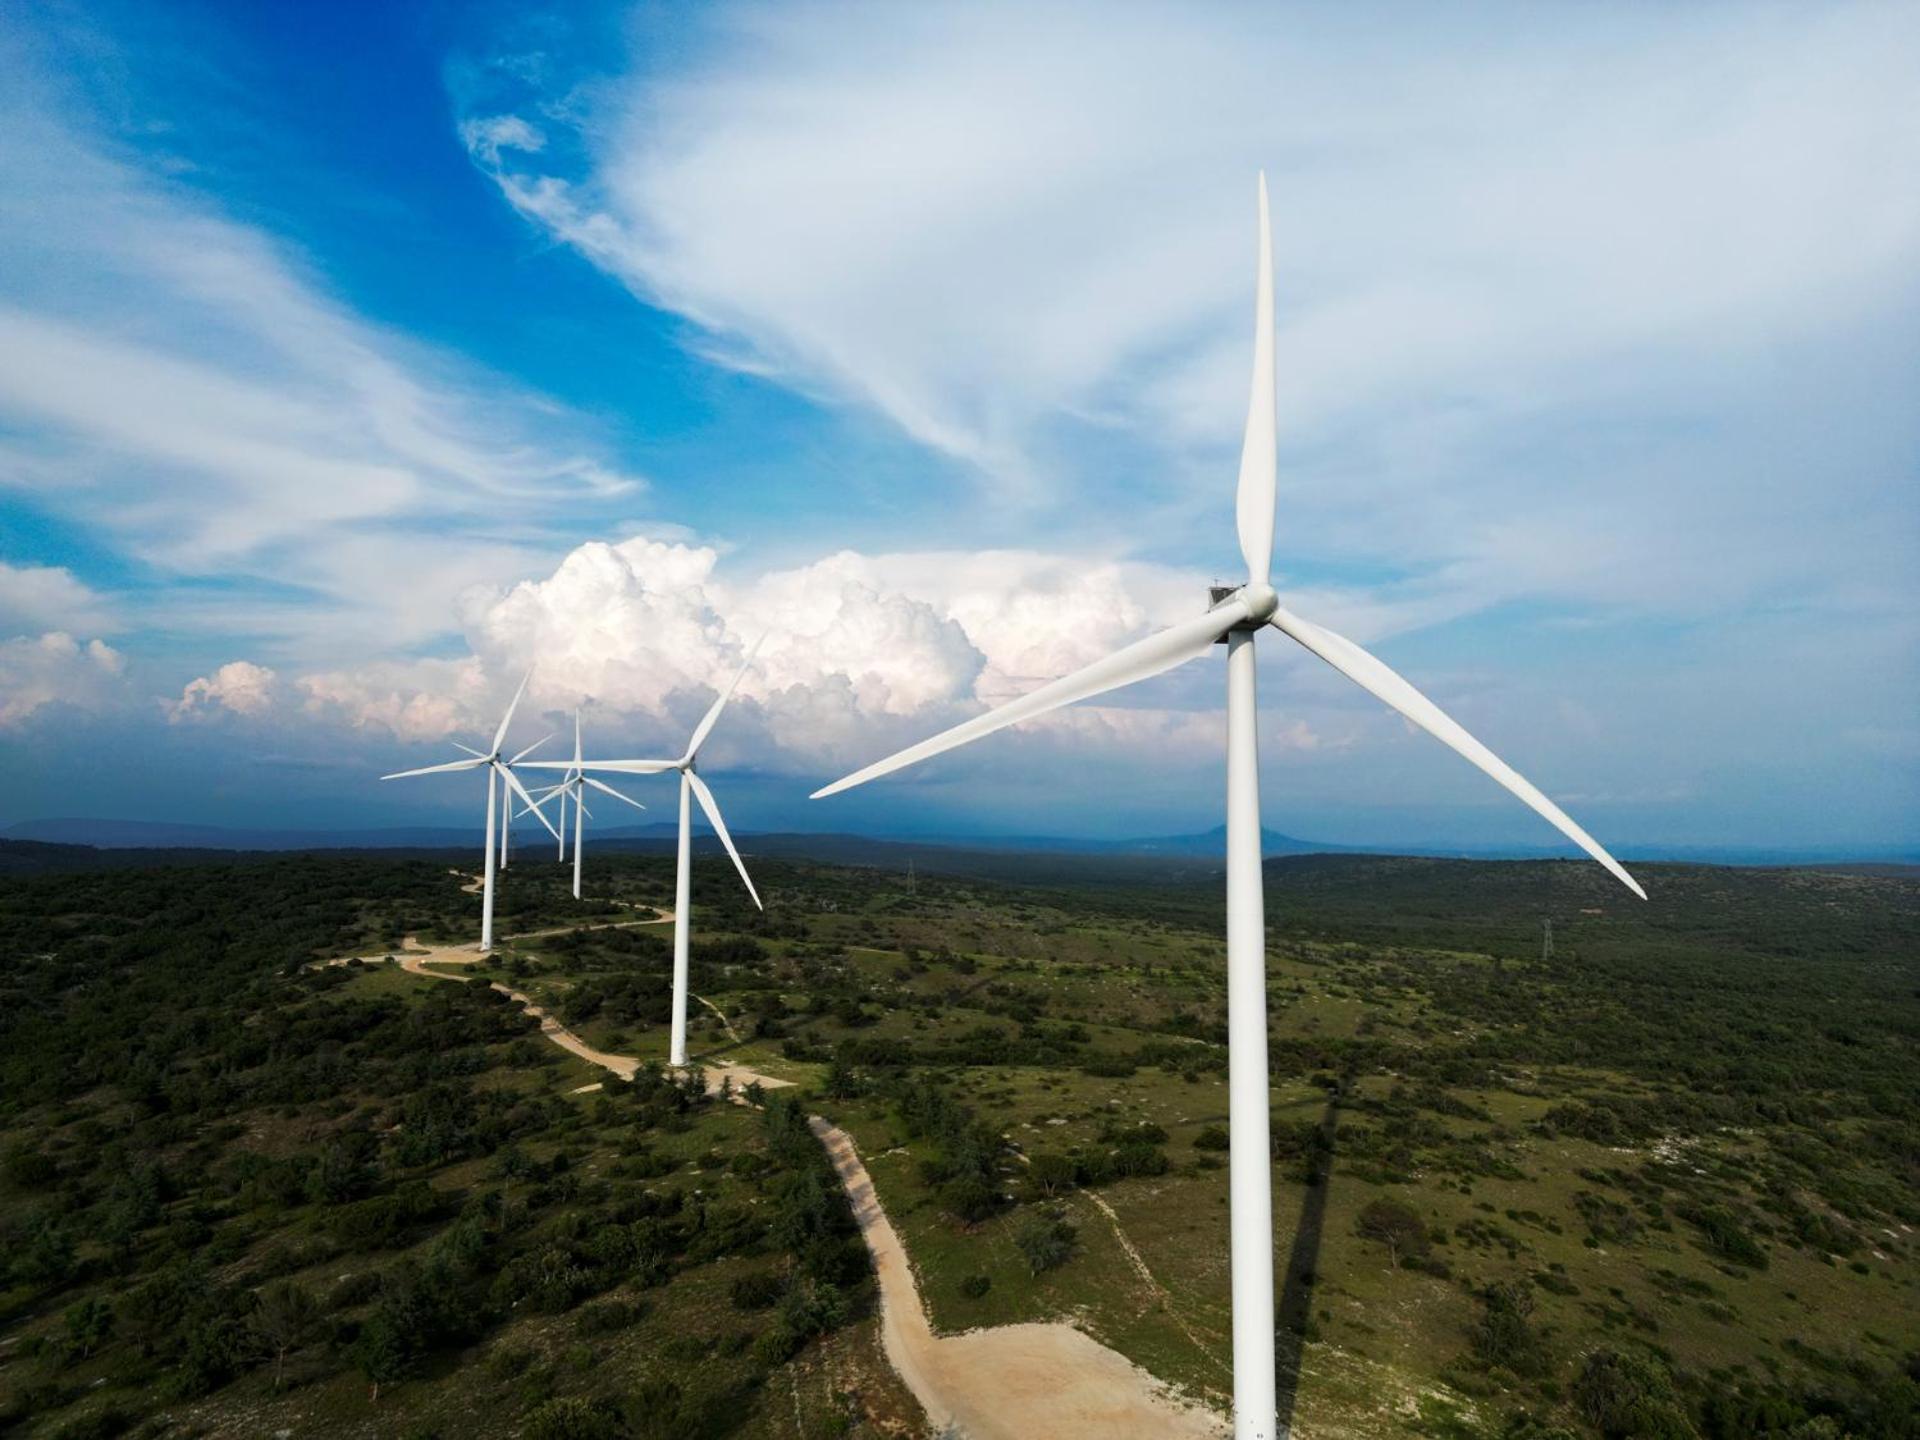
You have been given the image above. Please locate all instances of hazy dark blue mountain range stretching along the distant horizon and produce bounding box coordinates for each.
[0,818,1920,866]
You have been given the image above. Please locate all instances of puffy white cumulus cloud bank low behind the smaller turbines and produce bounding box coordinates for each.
[300,536,1244,768]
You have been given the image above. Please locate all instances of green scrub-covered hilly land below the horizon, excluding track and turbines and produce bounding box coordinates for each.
[0,856,1920,1440]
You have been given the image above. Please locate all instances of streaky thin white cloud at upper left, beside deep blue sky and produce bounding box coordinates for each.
[0,36,641,662]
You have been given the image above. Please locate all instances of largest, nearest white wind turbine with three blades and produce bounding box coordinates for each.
[814,175,1645,1440]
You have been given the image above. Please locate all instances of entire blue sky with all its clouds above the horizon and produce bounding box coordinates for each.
[0,4,1920,851]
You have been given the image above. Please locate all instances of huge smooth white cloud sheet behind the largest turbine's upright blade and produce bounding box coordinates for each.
[468,4,1920,614]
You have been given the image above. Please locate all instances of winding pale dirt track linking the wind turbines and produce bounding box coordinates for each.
[326,898,1227,1440]
